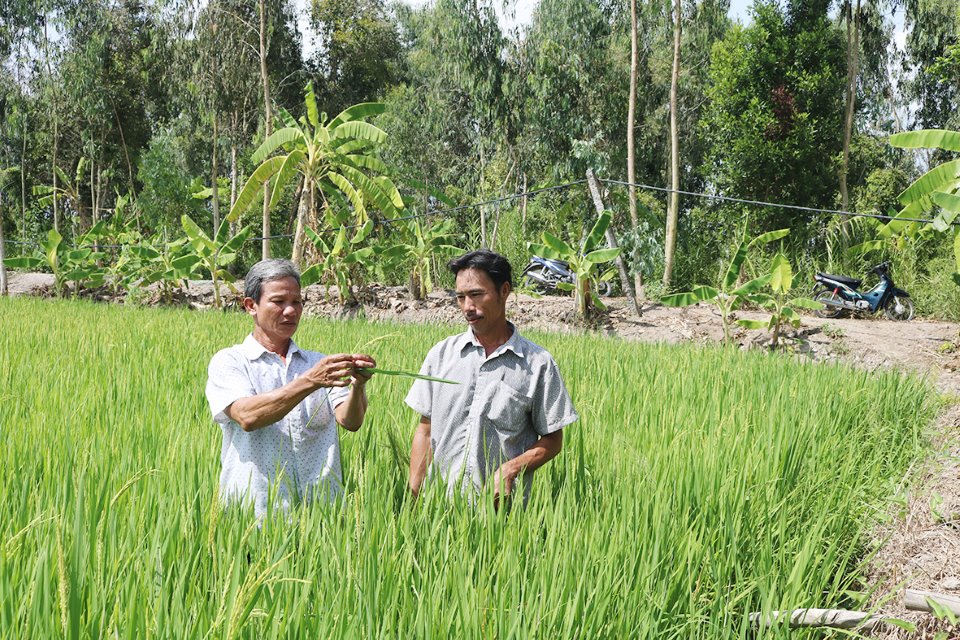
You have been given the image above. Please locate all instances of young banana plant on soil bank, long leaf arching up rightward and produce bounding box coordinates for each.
[660,229,790,342]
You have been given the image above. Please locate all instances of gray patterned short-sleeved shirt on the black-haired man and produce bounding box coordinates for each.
[406,328,578,496]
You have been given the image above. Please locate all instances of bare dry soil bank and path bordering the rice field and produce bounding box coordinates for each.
[9,273,960,639]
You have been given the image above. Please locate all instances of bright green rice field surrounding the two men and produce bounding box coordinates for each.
[0,299,936,639]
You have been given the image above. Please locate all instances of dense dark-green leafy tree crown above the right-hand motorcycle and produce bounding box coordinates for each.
[701,3,845,236]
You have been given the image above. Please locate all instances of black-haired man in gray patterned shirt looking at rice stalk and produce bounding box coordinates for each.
[406,249,577,503]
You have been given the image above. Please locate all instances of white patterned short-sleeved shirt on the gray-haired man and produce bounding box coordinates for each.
[207,335,350,517]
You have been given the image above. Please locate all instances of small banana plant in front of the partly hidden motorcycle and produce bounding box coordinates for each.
[527,211,620,318]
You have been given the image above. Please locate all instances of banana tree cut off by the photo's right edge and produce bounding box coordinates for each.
[878,129,960,285]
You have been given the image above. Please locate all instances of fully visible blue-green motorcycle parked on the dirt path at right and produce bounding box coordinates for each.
[813,262,913,321]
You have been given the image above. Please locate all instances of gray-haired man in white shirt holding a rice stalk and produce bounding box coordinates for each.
[206,260,376,518]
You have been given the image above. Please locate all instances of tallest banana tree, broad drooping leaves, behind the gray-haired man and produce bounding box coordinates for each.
[229,83,403,266]
